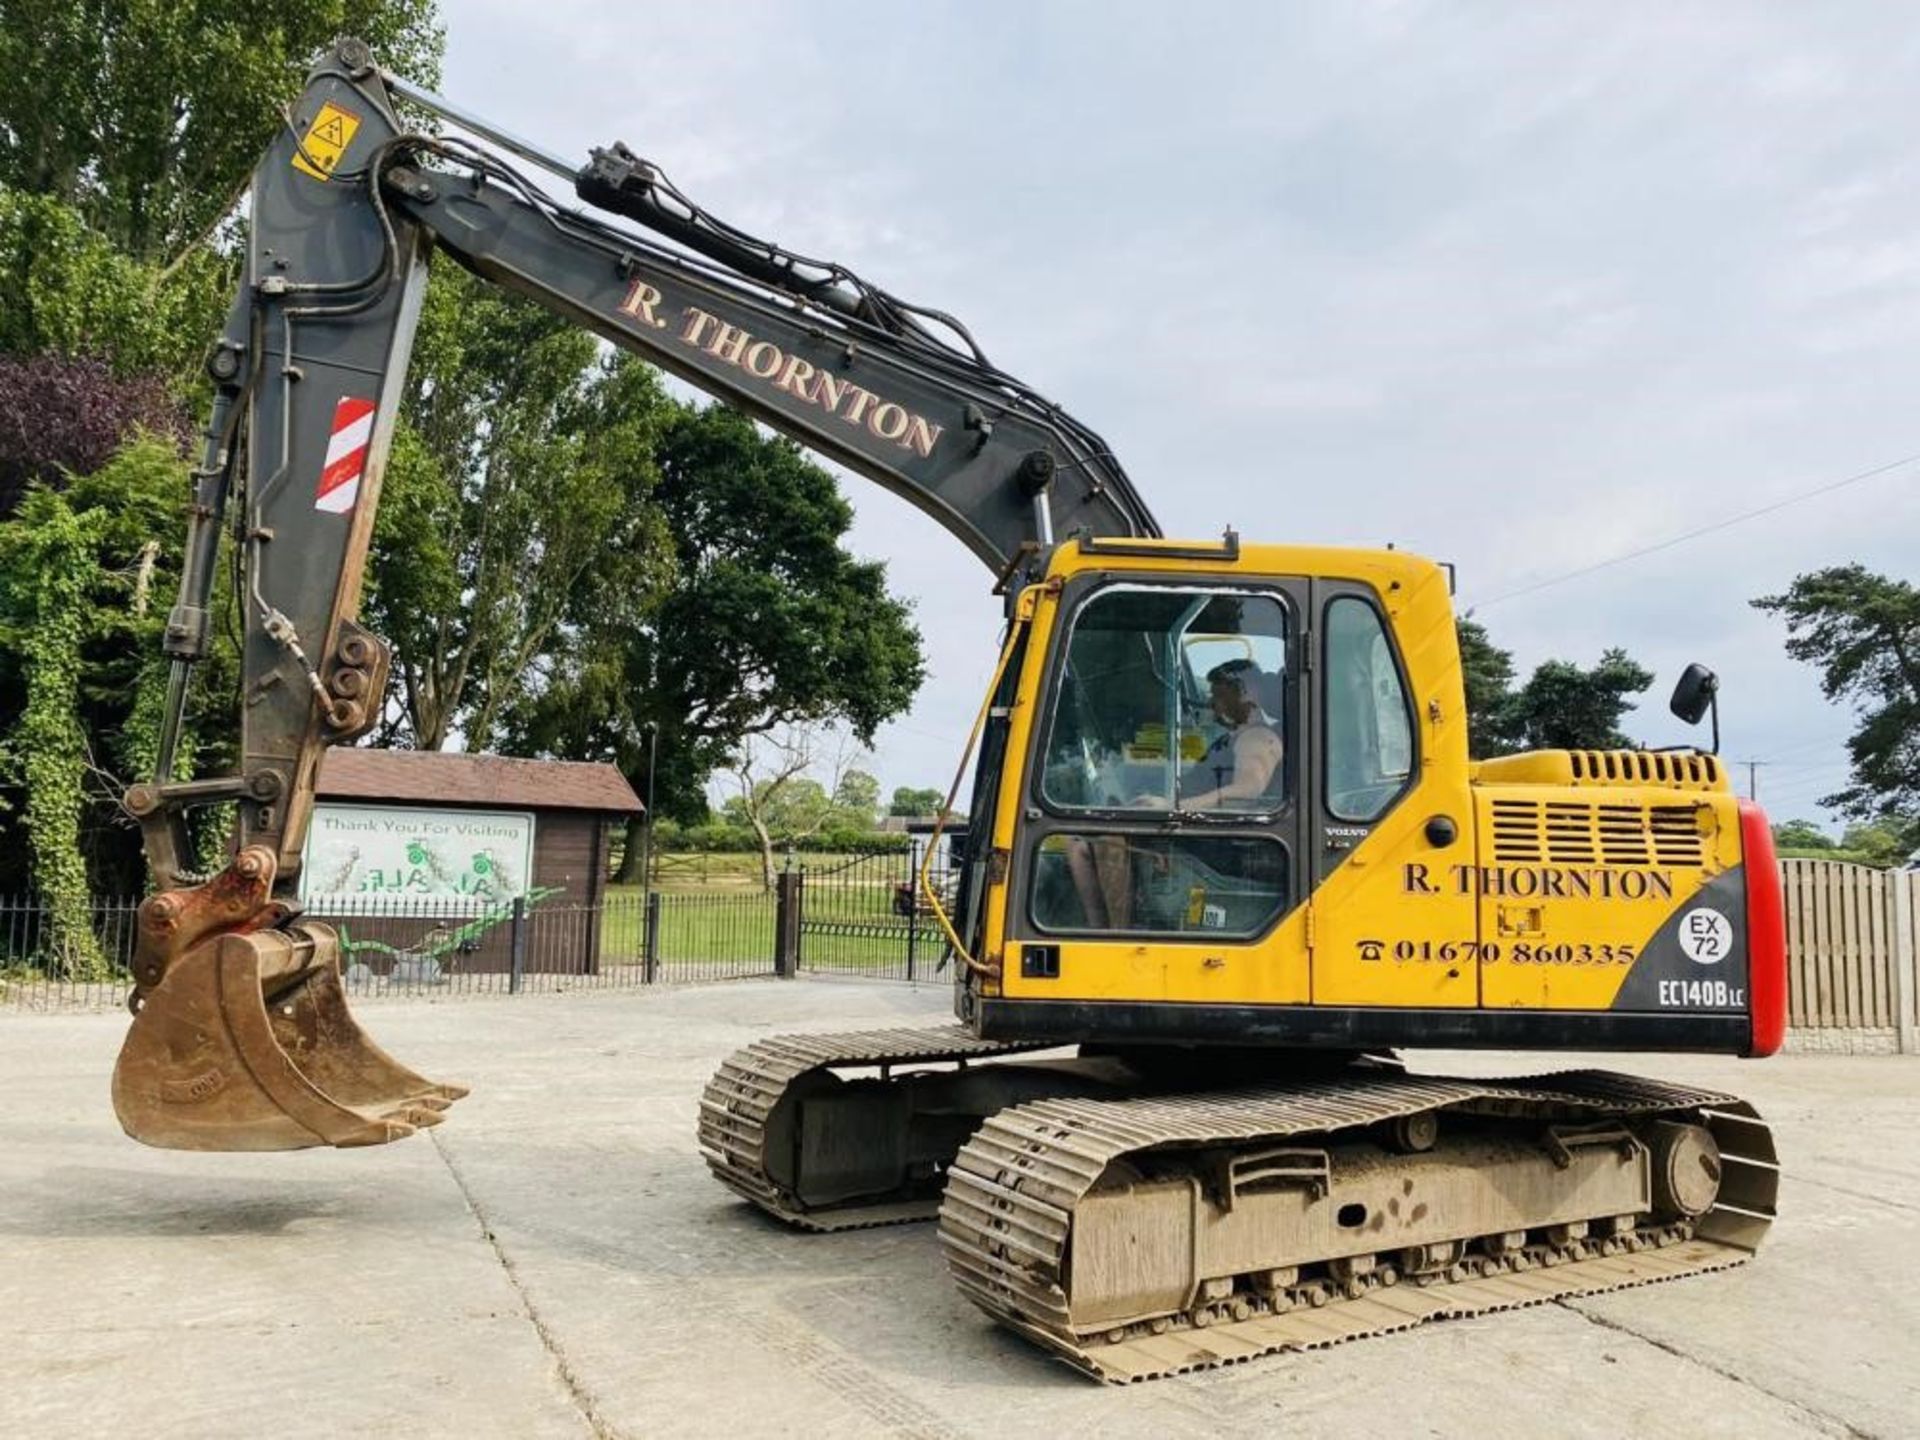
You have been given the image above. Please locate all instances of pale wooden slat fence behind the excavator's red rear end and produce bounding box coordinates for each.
[1780,860,1920,1050]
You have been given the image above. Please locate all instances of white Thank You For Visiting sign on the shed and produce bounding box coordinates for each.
[300,803,534,908]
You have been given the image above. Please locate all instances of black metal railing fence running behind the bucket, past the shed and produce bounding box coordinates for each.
[0,843,952,1010]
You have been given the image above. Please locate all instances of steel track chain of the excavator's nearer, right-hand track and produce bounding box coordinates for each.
[941,1071,1778,1382]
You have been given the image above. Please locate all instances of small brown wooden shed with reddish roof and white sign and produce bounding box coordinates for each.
[300,749,643,973]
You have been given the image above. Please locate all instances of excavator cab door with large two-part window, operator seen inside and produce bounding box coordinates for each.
[1000,572,1309,1004]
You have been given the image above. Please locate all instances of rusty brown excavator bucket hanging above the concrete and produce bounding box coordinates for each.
[113,906,467,1150]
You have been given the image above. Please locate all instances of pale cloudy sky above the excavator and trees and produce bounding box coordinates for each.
[444,0,1920,818]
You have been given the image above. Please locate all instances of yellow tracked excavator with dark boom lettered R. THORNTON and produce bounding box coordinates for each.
[113,40,1786,1380]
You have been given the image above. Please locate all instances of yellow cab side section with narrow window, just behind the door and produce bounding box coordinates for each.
[1304,580,1480,1008]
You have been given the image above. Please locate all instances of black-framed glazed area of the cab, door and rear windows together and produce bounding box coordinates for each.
[1010,574,1413,943]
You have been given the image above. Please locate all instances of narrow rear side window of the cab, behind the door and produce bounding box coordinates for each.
[1325,595,1413,824]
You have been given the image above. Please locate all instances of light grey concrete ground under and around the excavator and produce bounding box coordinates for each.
[0,979,1920,1440]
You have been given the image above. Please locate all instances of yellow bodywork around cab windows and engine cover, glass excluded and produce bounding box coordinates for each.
[981,541,1740,1010]
